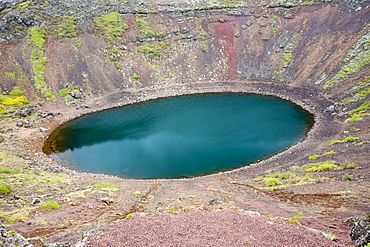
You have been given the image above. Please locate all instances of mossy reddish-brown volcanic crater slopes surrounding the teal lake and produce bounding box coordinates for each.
[0,0,370,246]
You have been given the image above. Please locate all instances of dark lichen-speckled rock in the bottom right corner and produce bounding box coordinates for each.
[349,215,370,246]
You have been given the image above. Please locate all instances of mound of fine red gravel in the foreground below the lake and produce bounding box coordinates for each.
[85,210,348,247]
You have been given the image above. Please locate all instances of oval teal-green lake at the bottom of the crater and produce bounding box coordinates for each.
[44,94,312,179]
